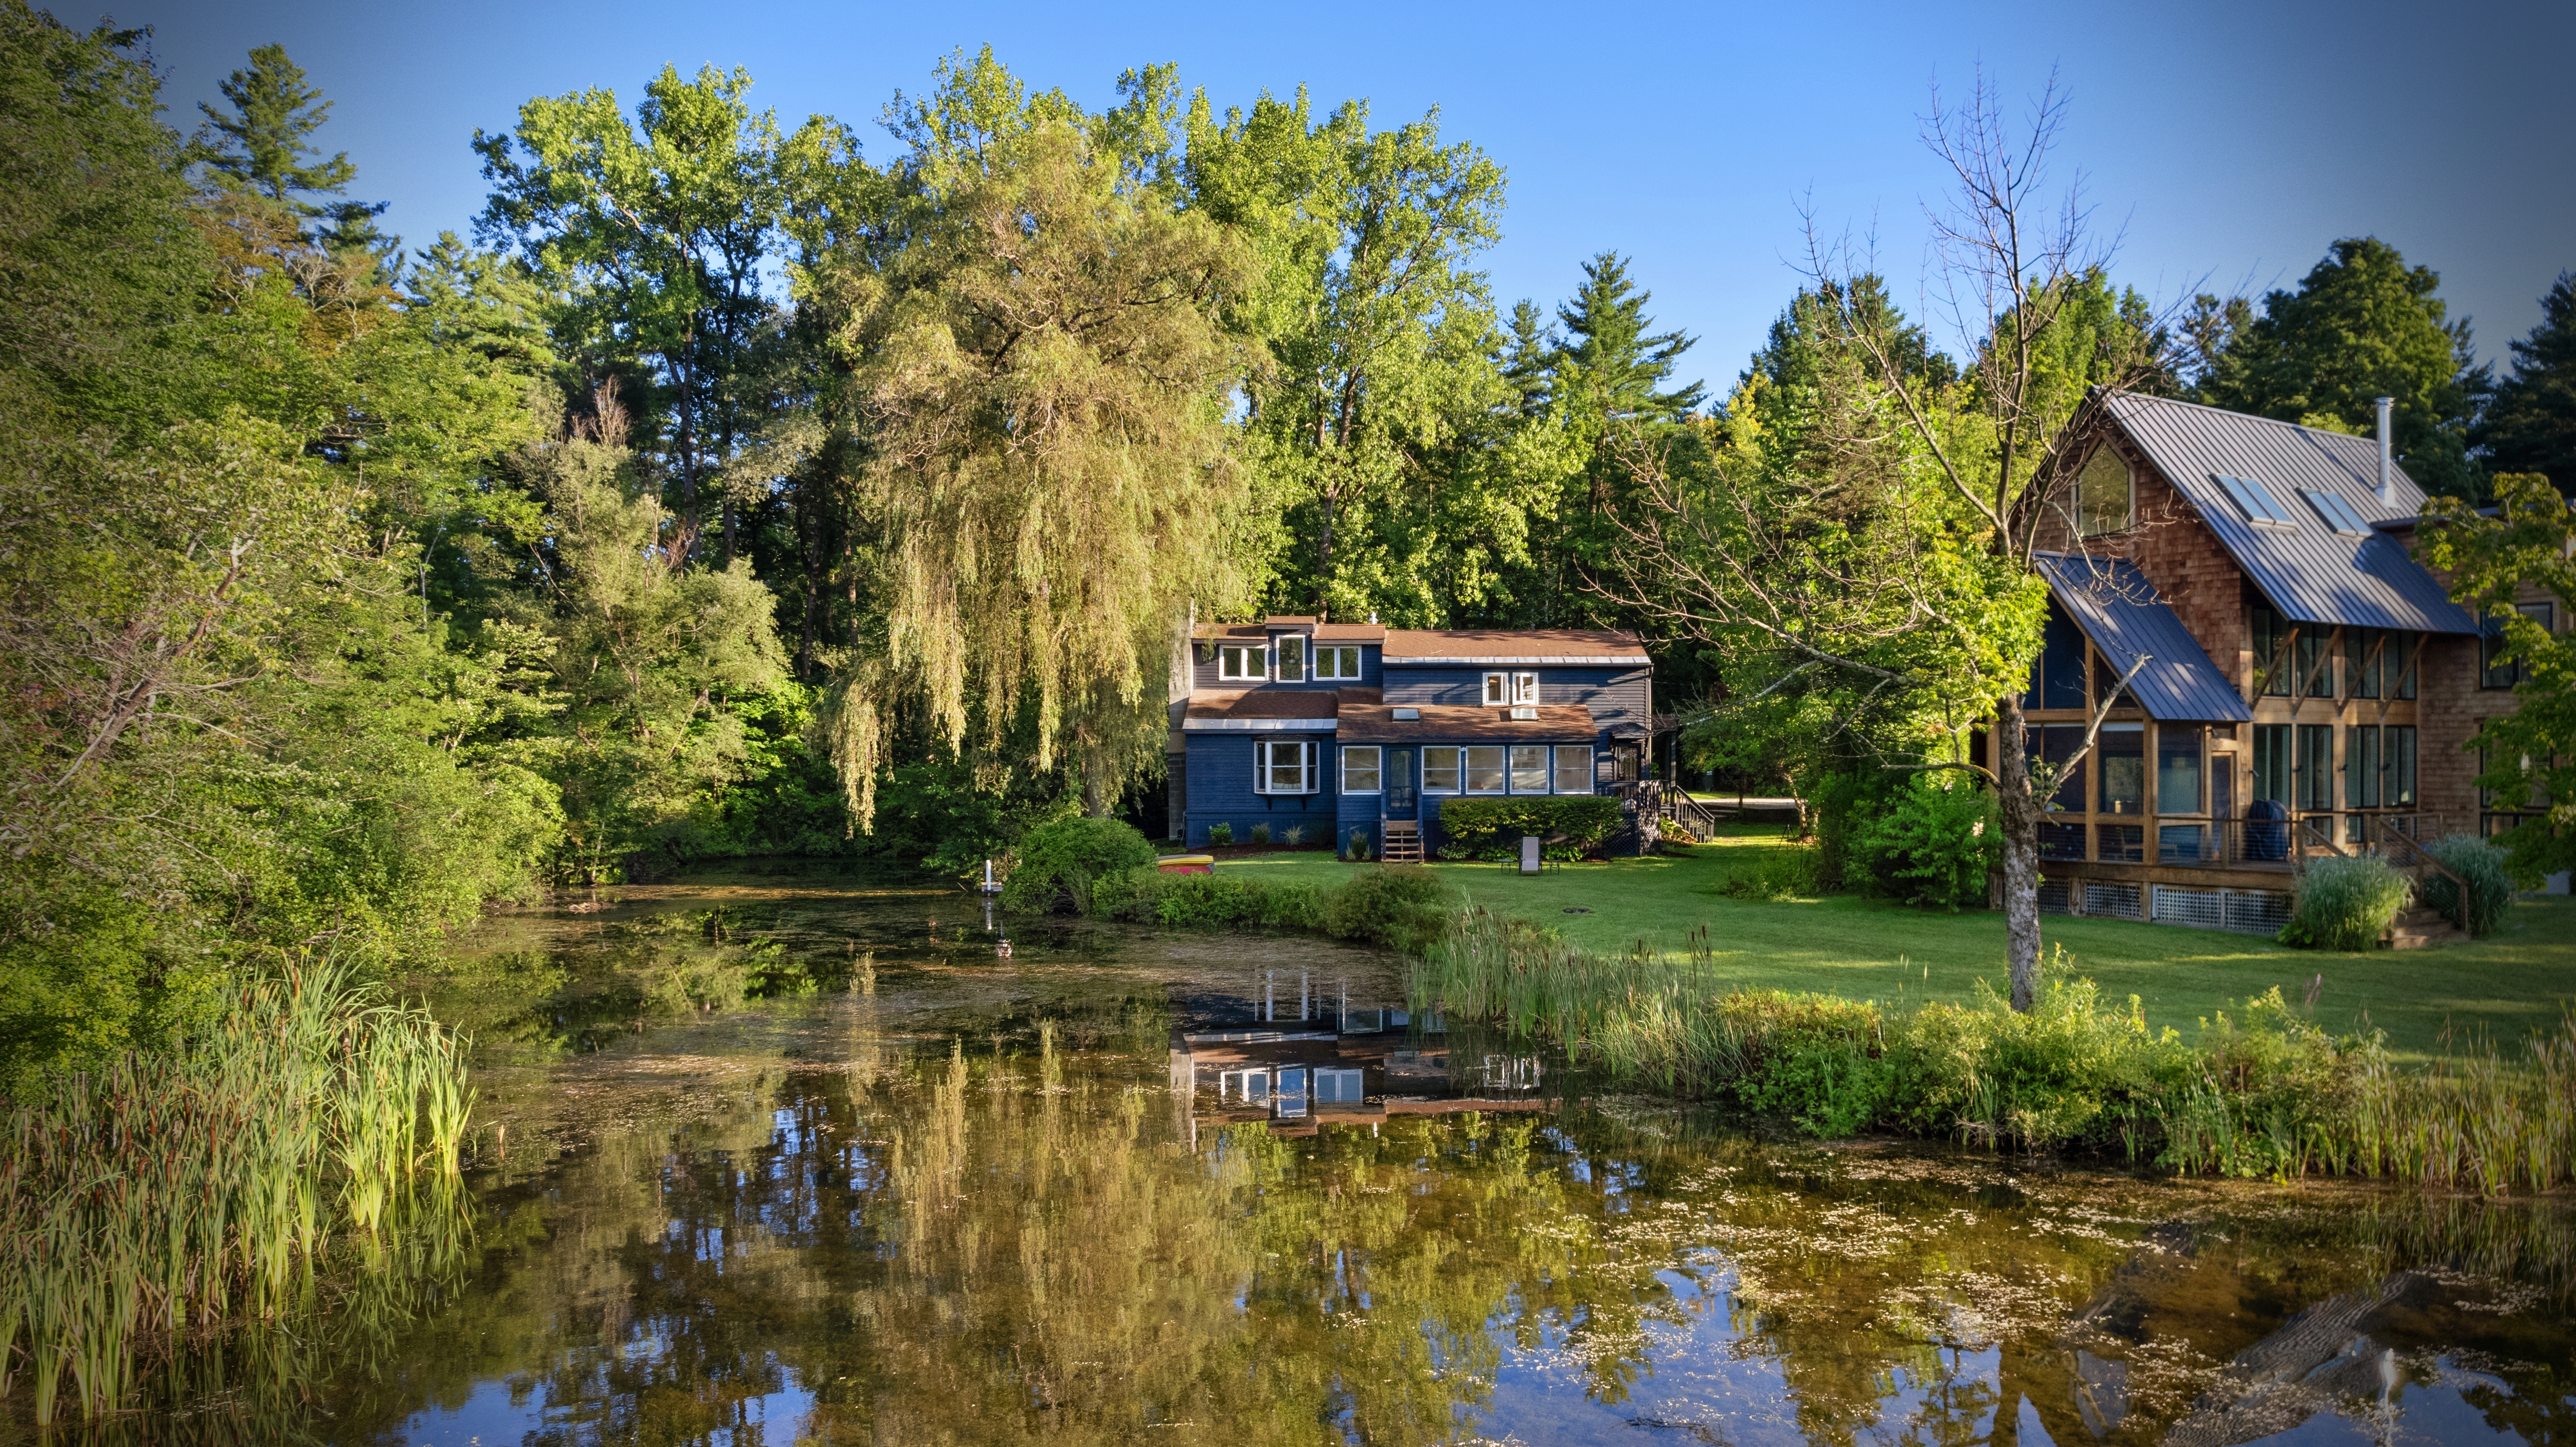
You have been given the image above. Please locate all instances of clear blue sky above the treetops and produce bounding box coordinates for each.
[111,0,2576,392]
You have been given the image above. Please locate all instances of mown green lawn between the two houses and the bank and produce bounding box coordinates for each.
[1218,837,2576,1053]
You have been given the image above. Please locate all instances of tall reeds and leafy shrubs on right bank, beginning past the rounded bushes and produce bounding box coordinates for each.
[1412,912,2576,1192]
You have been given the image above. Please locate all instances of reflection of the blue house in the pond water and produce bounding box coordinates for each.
[1172,968,1553,1143]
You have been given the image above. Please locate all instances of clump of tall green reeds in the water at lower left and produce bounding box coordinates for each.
[0,963,471,1424]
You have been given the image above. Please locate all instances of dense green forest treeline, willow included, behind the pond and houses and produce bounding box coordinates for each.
[0,0,2576,1074]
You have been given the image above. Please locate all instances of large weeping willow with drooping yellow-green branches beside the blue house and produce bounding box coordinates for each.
[812,116,1249,829]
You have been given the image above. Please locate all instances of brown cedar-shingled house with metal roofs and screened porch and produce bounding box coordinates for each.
[1979,392,2566,930]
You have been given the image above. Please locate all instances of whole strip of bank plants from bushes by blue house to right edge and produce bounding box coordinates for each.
[1005,819,2576,1195]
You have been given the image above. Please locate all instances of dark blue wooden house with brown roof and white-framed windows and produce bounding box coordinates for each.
[1164,615,1654,860]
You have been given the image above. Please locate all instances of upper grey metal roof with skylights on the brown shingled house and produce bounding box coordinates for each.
[2102,392,2478,633]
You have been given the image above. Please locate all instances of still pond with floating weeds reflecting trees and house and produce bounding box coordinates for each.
[171,865,2576,1447]
